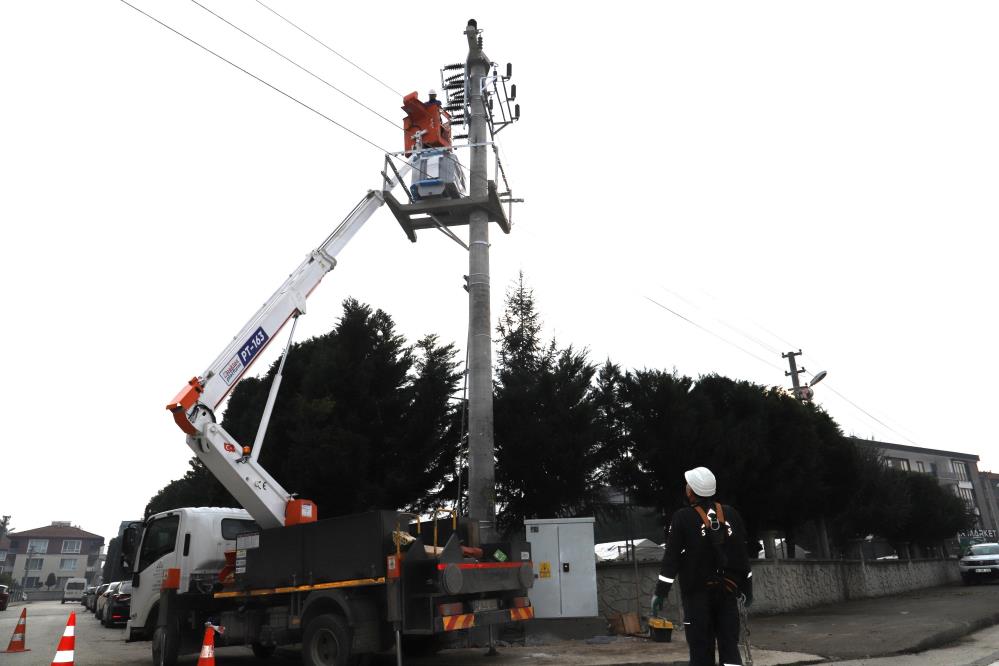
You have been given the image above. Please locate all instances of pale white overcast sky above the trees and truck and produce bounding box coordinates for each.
[0,0,999,538]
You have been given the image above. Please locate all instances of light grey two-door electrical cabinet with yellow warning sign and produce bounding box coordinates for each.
[524,518,597,618]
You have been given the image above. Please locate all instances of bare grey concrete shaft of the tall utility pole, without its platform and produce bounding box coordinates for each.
[465,19,496,543]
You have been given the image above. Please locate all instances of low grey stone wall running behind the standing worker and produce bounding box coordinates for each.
[597,559,961,618]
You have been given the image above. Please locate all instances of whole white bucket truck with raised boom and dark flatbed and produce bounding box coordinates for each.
[124,116,534,666]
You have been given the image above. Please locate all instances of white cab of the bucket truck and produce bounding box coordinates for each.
[125,507,259,640]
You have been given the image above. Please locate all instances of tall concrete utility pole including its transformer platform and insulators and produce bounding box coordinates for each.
[383,19,523,545]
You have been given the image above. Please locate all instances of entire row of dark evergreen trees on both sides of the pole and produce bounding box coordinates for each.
[146,282,974,551]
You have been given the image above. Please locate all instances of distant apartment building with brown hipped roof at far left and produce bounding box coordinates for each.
[5,521,104,590]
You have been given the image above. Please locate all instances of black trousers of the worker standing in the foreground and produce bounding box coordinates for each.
[683,586,742,666]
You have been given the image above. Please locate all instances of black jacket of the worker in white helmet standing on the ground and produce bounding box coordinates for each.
[656,500,753,599]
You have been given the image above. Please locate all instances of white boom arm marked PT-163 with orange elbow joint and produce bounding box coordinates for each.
[167,167,409,529]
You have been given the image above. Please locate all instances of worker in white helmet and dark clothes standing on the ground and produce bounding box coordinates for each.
[652,467,753,666]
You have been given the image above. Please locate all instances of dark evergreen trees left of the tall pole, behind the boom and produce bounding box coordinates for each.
[146,299,460,517]
